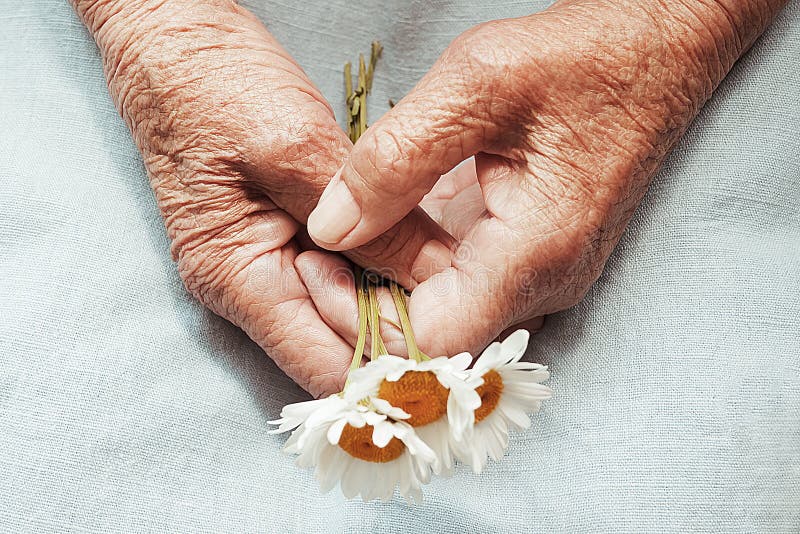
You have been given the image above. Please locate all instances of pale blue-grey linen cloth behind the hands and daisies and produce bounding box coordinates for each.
[0,0,800,533]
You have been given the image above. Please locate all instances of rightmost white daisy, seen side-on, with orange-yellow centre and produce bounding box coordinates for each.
[454,330,552,473]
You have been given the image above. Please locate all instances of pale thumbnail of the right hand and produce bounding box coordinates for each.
[308,169,361,244]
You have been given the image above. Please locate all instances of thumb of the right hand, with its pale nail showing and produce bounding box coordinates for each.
[308,79,489,250]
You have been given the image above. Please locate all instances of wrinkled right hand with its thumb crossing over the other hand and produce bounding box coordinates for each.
[308,0,782,355]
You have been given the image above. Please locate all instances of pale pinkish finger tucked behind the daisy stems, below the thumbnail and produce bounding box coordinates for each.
[295,251,407,356]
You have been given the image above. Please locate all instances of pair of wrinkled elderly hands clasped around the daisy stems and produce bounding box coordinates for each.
[75,0,781,395]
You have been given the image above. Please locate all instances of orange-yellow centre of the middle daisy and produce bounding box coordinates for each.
[378,371,449,426]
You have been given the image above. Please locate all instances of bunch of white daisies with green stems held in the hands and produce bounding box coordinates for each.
[272,43,551,501]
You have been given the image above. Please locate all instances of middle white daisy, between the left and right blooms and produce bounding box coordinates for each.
[345,352,482,475]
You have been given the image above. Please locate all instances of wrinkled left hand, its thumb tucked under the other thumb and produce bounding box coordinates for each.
[76,0,451,394]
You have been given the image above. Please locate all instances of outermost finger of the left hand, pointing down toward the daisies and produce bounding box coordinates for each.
[179,203,353,396]
